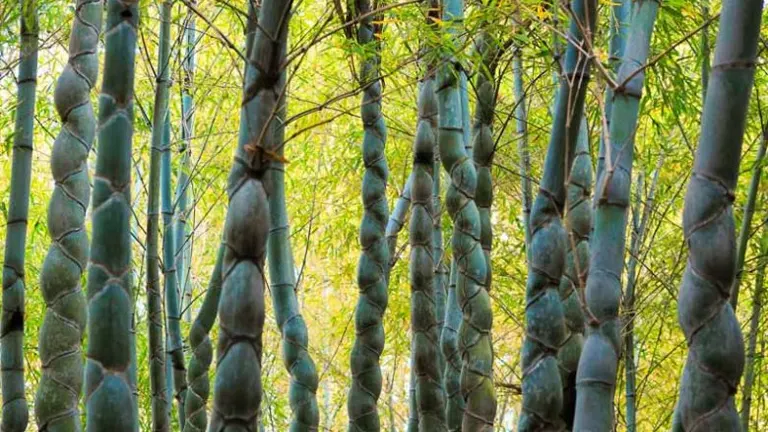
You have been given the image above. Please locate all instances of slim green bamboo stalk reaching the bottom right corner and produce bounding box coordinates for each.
[741,216,768,430]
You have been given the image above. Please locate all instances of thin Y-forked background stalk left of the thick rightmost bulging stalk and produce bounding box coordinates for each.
[623,158,663,432]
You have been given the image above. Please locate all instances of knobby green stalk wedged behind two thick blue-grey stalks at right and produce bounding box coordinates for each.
[557,116,592,430]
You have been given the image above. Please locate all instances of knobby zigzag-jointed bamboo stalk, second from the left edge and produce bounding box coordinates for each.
[34,0,103,431]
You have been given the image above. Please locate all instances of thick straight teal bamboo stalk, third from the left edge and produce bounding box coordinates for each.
[84,0,139,432]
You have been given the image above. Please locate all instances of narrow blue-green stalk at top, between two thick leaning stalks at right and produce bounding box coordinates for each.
[595,0,632,180]
